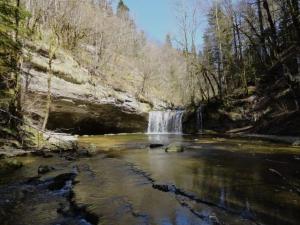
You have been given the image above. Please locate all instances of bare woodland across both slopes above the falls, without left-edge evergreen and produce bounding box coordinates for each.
[10,0,300,111]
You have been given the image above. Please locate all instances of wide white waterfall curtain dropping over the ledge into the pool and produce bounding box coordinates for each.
[148,110,184,134]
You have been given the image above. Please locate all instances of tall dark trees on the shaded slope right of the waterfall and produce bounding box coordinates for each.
[176,0,300,109]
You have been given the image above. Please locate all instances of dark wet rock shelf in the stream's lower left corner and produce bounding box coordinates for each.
[0,150,99,225]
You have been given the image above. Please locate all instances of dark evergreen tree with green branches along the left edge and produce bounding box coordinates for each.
[0,0,27,137]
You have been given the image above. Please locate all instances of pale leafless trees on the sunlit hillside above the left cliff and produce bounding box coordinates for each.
[24,0,186,105]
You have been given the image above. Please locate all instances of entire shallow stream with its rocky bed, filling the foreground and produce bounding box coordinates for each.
[0,134,300,225]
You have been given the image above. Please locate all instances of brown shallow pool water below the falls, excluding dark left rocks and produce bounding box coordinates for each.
[0,134,300,225]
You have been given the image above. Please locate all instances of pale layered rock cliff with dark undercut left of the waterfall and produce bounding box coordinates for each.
[22,42,151,134]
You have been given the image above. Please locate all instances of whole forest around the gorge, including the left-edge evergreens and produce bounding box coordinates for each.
[1,0,300,142]
